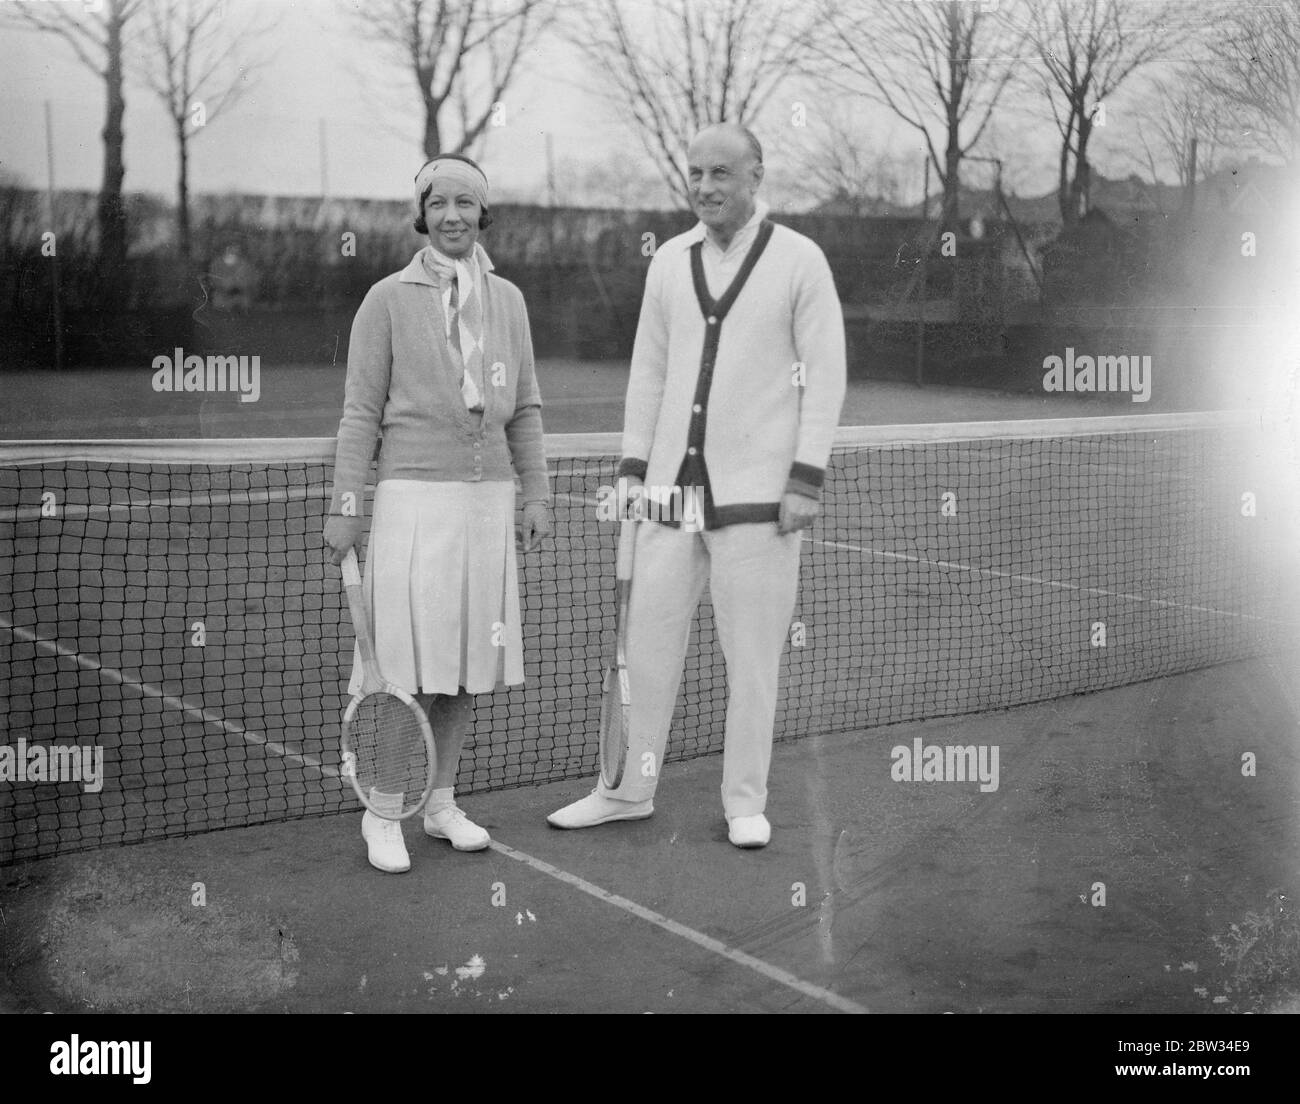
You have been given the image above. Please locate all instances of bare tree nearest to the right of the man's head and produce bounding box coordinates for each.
[818,0,1024,226]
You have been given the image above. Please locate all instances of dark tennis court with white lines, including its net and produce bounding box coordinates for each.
[0,382,1300,1012]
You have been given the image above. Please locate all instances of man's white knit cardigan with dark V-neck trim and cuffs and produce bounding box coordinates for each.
[619,225,846,529]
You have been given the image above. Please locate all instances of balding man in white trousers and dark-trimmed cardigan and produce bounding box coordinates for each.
[547,124,845,848]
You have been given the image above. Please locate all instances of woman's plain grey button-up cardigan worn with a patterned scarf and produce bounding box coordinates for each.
[330,255,550,516]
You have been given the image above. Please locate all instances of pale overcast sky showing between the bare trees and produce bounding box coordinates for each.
[0,0,1227,209]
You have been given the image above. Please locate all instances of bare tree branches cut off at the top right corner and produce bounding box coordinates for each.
[1197,0,1300,165]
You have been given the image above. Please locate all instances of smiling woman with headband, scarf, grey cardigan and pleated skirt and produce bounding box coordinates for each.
[325,153,551,873]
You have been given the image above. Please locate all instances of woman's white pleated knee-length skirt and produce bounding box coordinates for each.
[350,480,524,694]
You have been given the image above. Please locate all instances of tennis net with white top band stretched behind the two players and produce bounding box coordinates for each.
[0,415,1300,863]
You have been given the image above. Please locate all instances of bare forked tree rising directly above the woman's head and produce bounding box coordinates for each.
[351,0,554,157]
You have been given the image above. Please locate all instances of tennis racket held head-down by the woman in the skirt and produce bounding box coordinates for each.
[342,549,436,821]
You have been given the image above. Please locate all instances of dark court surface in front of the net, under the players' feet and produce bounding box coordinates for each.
[0,655,1300,1013]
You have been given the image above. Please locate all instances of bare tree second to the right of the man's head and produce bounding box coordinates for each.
[1030,0,1191,226]
